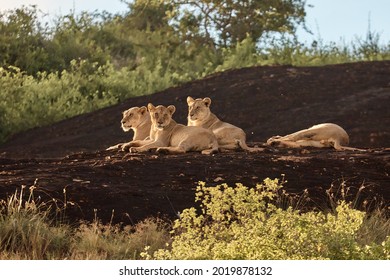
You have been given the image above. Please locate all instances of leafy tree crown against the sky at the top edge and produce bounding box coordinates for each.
[165,0,306,47]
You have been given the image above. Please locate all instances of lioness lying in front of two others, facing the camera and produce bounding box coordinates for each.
[130,103,218,154]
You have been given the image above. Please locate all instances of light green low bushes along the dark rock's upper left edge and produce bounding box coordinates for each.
[0,60,175,142]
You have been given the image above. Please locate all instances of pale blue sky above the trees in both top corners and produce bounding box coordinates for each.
[0,0,390,44]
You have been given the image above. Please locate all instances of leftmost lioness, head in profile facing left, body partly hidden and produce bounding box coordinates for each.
[107,106,152,150]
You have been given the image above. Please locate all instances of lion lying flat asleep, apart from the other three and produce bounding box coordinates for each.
[267,123,363,151]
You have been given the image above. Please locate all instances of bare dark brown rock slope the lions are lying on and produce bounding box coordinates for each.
[0,61,390,223]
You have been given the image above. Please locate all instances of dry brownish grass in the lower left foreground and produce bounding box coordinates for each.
[0,187,169,260]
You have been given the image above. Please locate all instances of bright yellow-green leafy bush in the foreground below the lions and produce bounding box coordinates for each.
[149,179,390,259]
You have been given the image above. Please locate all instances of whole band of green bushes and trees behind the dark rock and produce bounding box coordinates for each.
[0,0,390,143]
